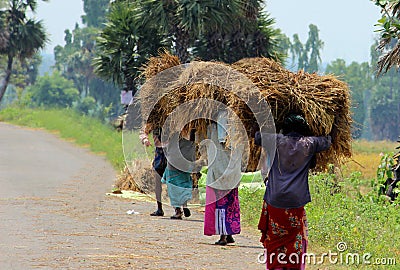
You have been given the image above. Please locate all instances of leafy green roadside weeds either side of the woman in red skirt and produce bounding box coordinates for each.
[239,172,400,269]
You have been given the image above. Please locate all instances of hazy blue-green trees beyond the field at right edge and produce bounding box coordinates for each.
[325,39,400,141]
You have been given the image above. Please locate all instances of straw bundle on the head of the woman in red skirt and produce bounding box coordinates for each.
[231,58,352,168]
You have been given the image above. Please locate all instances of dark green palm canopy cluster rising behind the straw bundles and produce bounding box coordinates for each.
[94,0,282,95]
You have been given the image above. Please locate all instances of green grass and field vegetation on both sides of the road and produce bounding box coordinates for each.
[0,108,400,269]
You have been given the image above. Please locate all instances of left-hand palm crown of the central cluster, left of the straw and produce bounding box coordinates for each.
[93,1,166,93]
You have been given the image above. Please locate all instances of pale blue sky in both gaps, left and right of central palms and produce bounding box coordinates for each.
[36,0,380,63]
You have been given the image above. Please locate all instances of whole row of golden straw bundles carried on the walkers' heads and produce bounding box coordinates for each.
[139,52,352,171]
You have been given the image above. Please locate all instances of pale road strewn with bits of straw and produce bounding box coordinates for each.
[0,123,265,269]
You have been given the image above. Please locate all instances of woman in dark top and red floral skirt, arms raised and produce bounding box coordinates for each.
[255,114,331,270]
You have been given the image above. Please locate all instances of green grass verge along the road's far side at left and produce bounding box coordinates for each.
[0,107,124,170]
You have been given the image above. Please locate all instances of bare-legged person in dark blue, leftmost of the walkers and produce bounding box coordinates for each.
[139,125,167,216]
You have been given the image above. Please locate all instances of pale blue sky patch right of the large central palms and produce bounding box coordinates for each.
[266,0,380,63]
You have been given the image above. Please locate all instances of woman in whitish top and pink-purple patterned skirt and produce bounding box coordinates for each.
[204,112,242,246]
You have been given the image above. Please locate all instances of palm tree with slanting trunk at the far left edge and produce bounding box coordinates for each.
[0,0,47,102]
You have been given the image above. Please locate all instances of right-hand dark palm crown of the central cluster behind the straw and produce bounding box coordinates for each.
[194,1,284,63]
